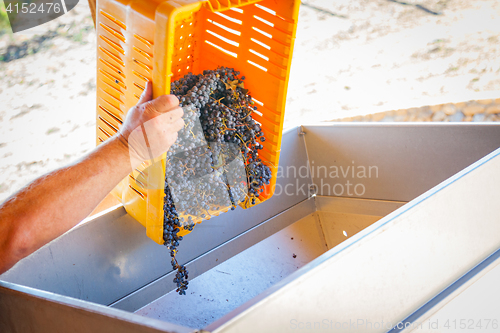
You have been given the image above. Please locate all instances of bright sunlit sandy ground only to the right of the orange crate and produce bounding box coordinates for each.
[286,0,500,125]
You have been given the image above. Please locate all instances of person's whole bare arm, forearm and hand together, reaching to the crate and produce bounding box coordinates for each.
[0,82,184,274]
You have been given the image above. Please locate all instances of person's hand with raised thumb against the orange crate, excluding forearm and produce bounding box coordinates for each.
[118,82,184,168]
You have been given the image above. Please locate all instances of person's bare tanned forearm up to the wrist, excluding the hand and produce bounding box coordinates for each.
[0,137,131,274]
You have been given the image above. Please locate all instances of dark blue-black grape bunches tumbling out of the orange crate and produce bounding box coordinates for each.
[163,67,271,295]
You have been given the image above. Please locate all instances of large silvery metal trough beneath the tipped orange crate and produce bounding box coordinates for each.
[0,123,500,333]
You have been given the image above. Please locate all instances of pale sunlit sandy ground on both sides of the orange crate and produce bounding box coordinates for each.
[0,0,500,202]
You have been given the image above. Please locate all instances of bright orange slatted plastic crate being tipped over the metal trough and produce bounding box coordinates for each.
[96,0,300,244]
